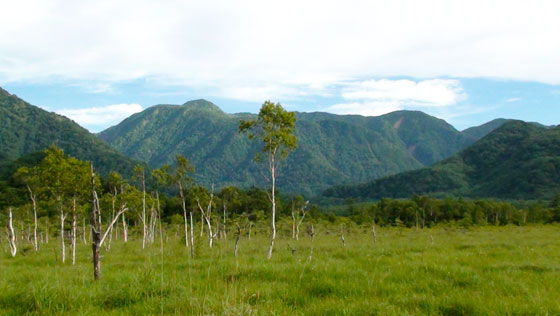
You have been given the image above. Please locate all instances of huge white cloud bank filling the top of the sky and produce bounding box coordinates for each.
[0,0,560,103]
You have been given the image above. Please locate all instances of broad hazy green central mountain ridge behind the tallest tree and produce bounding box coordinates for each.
[98,100,486,194]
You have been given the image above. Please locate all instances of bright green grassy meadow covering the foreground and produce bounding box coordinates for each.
[0,226,560,315]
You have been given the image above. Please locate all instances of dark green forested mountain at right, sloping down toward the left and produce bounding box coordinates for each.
[324,120,560,199]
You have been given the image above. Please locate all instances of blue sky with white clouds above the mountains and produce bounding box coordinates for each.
[0,0,560,132]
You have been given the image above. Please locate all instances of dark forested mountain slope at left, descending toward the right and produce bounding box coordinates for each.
[0,88,137,174]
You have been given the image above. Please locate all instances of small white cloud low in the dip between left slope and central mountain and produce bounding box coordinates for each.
[56,103,142,132]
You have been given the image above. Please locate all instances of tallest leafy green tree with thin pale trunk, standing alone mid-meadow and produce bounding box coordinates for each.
[239,101,297,259]
